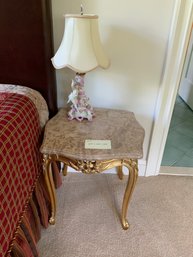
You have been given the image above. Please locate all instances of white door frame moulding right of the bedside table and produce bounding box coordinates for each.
[145,0,193,176]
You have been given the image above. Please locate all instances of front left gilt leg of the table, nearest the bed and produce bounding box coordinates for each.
[43,154,56,225]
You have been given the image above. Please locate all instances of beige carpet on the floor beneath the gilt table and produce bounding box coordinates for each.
[38,173,193,257]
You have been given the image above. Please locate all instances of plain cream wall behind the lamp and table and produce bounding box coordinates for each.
[52,0,175,172]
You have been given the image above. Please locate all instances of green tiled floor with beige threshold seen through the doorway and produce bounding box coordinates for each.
[160,94,193,175]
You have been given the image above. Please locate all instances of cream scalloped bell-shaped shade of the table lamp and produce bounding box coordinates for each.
[51,14,109,73]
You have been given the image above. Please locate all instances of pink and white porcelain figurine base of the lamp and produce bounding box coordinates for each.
[68,73,94,121]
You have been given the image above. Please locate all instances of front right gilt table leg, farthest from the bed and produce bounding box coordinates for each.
[121,159,138,230]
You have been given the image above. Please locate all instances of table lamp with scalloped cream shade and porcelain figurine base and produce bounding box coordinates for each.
[51,9,109,121]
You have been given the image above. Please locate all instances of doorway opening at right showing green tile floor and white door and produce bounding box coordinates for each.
[160,24,193,176]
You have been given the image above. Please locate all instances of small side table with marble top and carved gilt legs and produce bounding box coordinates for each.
[40,108,144,229]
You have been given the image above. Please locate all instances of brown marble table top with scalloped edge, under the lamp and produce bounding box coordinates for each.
[40,108,145,160]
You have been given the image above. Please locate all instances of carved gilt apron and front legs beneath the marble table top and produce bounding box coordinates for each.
[43,154,138,229]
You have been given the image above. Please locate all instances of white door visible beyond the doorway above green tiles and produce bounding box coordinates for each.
[179,26,193,110]
